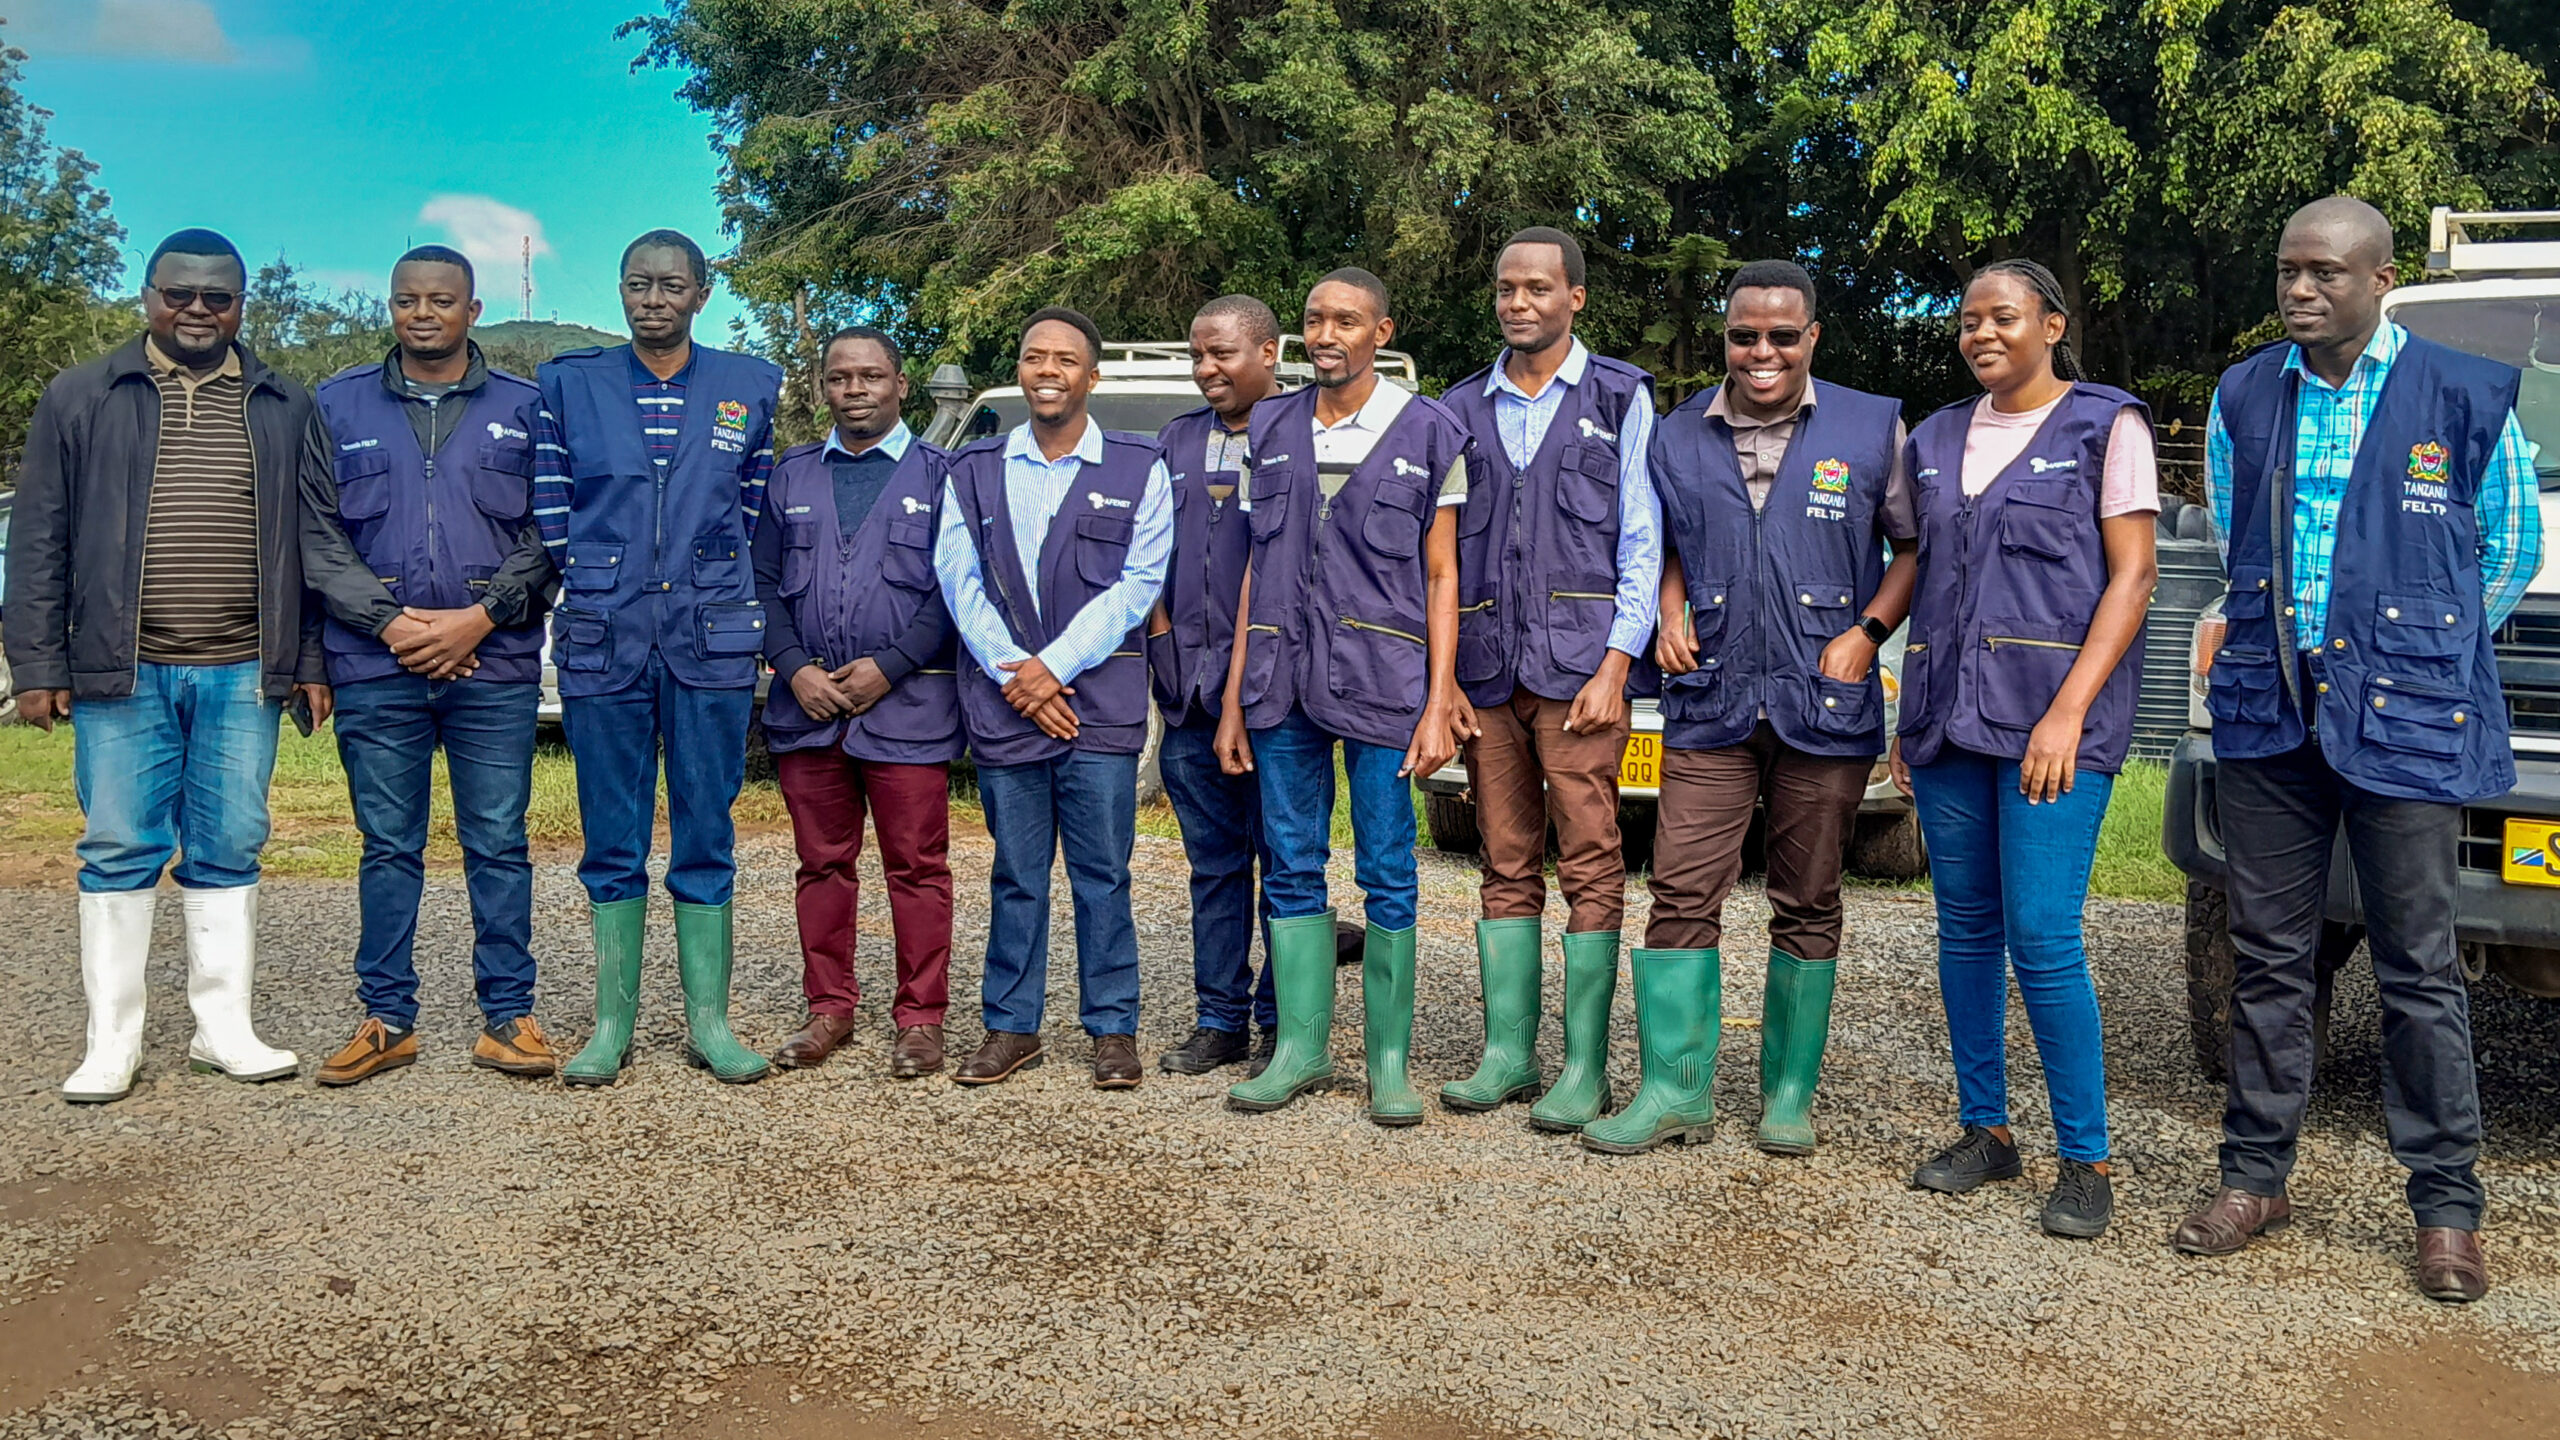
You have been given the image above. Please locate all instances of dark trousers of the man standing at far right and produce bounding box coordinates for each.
[2220,740,2483,1230]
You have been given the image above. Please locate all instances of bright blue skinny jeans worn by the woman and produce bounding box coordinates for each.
[1912,746,2115,1163]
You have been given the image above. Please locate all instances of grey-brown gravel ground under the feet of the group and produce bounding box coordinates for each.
[0,819,2560,1440]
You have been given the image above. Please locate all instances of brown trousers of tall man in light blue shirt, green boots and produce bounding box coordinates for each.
[1467,689,1628,935]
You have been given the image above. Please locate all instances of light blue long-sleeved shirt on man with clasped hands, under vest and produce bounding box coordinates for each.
[934,418,1172,684]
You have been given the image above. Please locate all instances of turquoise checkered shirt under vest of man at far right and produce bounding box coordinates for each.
[2204,323,2542,651]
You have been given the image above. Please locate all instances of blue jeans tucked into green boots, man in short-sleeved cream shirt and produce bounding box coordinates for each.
[1252,710,1418,930]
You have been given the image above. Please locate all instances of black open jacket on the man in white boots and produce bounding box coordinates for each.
[0,336,330,700]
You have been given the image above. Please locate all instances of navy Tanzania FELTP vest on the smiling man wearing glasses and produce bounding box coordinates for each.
[1651,379,1902,758]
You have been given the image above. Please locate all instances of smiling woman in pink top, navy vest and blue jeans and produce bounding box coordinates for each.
[1892,261,2161,1238]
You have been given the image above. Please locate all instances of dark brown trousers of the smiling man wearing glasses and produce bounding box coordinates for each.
[1644,720,1874,961]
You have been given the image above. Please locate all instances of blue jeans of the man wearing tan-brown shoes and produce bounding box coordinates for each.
[335,674,543,1030]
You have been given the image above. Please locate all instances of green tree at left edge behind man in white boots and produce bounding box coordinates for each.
[0,23,131,474]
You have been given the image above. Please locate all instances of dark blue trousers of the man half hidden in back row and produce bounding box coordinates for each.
[1157,717,1280,1035]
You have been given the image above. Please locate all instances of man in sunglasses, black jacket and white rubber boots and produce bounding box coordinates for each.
[0,231,330,1104]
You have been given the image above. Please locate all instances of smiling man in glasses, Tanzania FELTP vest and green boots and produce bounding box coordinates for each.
[1582,261,1920,1156]
